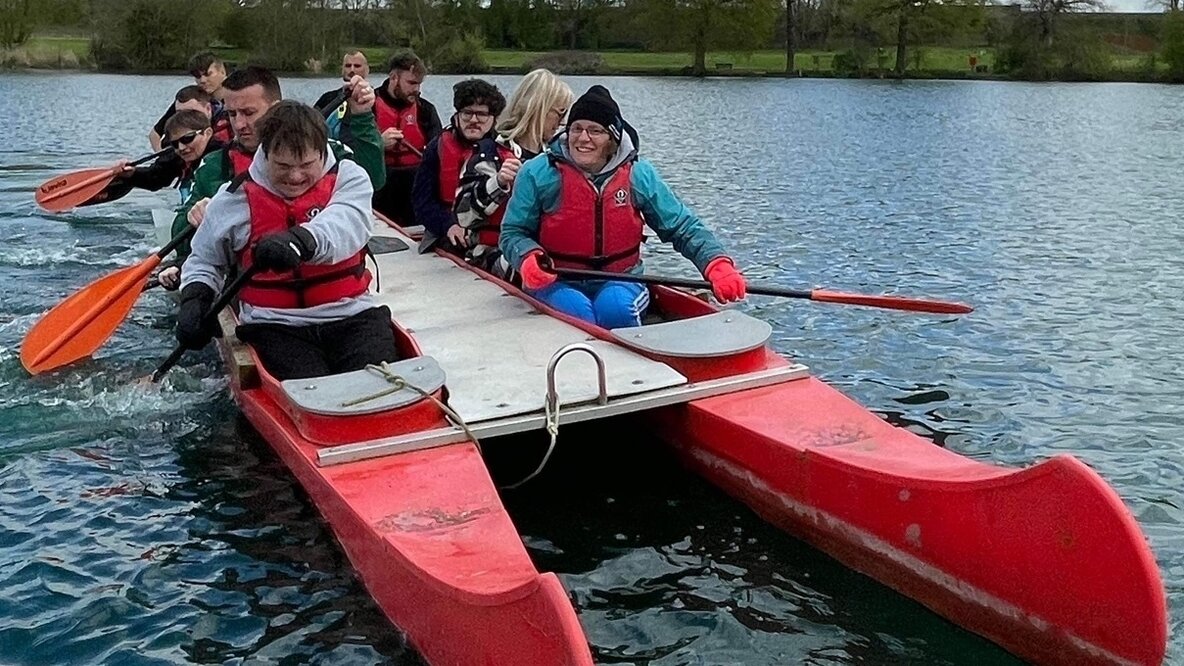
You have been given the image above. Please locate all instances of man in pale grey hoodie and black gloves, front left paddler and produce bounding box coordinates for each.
[176,101,395,379]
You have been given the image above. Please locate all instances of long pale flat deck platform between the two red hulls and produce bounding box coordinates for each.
[375,230,687,423]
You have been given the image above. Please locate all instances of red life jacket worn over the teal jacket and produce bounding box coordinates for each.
[539,160,645,273]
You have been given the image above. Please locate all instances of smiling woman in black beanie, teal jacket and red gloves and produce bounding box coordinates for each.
[500,85,747,328]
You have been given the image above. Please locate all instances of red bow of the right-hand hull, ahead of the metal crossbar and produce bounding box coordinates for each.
[656,378,1167,666]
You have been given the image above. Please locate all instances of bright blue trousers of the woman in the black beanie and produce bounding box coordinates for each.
[530,280,650,328]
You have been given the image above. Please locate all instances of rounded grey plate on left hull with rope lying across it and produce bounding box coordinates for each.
[279,357,444,416]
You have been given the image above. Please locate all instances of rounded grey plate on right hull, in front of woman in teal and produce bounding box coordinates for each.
[612,309,773,358]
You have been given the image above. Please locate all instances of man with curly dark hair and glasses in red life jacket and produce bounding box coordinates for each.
[411,78,506,250]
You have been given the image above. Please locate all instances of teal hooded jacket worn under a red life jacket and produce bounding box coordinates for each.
[498,133,726,273]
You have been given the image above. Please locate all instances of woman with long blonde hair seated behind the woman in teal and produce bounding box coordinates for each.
[452,69,574,277]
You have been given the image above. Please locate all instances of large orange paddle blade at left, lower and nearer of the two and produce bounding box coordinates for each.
[20,255,160,374]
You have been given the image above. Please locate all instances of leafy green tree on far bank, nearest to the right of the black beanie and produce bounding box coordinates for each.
[633,0,780,76]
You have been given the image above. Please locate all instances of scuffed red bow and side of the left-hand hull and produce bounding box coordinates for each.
[234,369,592,666]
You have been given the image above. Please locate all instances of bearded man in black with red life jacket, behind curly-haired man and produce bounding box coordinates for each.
[374,51,442,226]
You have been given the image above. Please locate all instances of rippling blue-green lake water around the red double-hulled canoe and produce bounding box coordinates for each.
[0,73,1184,665]
